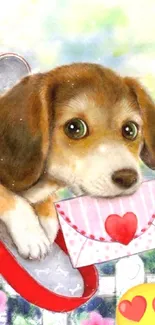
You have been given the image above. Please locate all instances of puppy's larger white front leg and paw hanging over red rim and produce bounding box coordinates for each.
[0,185,50,259]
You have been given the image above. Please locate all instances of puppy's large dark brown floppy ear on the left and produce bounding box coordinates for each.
[0,74,48,191]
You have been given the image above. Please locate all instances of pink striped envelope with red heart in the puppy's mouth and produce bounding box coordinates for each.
[56,180,155,267]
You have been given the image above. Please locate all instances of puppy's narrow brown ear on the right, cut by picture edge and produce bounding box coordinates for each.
[125,78,155,169]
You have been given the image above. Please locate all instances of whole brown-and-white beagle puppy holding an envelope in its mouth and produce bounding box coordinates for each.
[0,63,155,259]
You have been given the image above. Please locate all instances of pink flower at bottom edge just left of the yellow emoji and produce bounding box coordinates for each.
[82,312,115,325]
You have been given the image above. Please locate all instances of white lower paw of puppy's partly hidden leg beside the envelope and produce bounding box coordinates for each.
[39,216,59,244]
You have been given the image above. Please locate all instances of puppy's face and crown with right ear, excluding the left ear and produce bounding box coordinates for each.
[47,64,155,196]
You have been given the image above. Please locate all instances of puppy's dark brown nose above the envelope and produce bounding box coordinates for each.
[112,169,138,189]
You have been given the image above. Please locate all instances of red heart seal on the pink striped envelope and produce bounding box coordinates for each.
[105,212,138,245]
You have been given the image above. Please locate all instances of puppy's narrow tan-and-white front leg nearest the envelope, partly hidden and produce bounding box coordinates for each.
[33,194,59,244]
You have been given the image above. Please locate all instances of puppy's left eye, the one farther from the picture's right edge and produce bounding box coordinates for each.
[64,118,88,140]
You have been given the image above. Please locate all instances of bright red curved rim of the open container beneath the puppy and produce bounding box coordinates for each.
[0,231,98,312]
